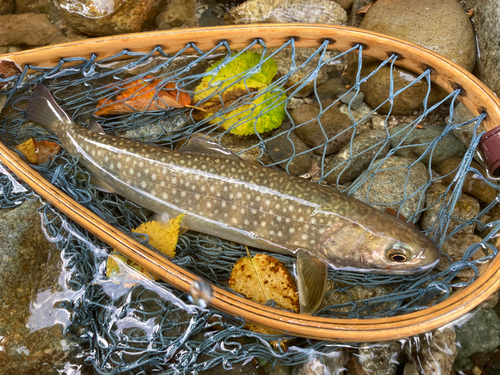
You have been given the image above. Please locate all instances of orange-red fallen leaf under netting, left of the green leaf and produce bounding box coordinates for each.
[95,76,191,116]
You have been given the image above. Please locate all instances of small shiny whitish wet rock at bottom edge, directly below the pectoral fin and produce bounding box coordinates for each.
[292,350,349,375]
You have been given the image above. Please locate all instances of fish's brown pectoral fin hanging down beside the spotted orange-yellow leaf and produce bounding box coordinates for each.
[297,251,328,314]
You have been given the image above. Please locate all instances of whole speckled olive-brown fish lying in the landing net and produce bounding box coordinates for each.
[26,85,439,313]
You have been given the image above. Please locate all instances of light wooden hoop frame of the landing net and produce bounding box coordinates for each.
[0,24,500,342]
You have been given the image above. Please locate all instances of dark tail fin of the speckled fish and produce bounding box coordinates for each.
[24,83,73,132]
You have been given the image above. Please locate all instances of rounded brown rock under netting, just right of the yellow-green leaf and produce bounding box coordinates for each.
[290,104,353,155]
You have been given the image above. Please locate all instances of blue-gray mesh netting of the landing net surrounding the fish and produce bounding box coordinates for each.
[0,40,500,374]
